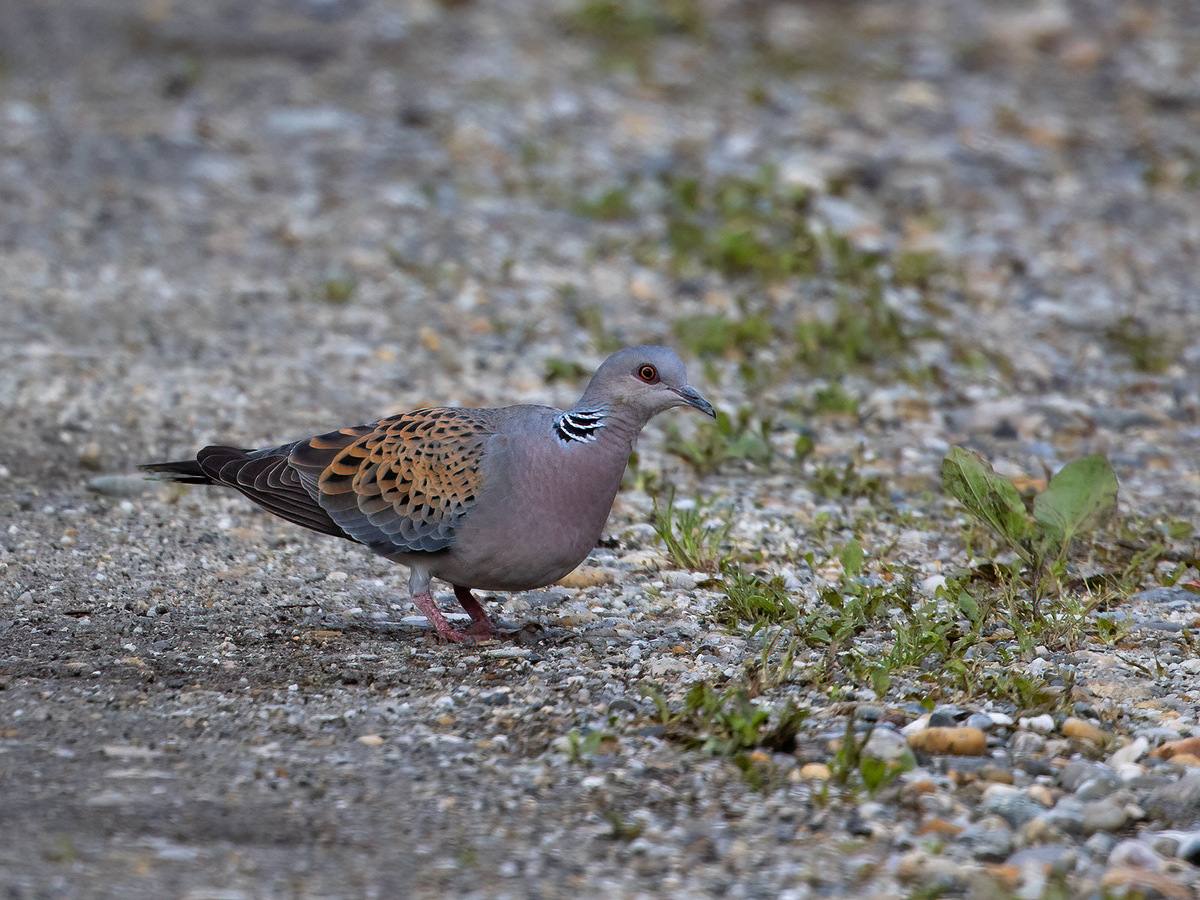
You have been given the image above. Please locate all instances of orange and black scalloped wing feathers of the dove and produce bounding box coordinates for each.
[288,409,496,554]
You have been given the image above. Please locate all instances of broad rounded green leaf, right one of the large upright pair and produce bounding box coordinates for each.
[1033,455,1117,556]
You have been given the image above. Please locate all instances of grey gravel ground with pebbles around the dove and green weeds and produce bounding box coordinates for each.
[0,0,1200,900]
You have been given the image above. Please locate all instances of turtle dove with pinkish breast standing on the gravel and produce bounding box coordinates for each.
[139,346,716,643]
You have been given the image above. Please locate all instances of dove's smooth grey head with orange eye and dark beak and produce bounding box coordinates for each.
[575,347,716,422]
